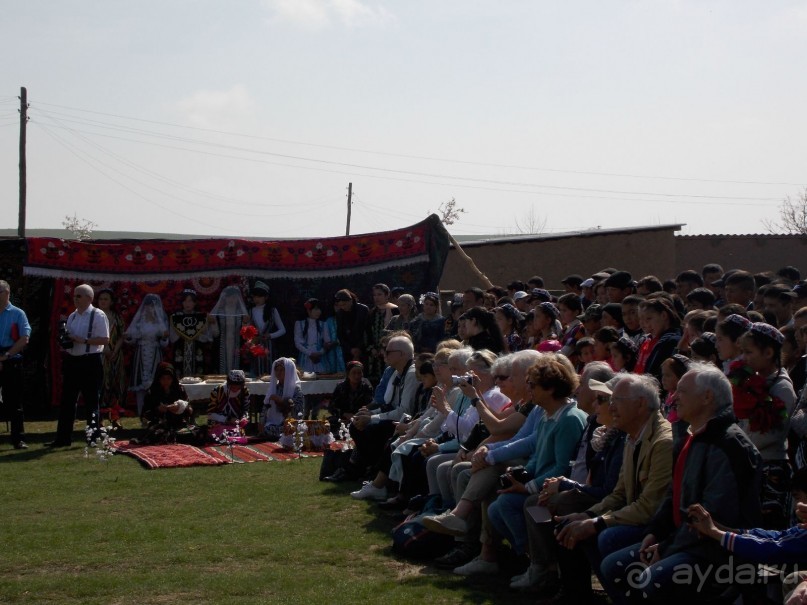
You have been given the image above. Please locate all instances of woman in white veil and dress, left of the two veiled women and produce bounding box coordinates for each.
[126,294,168,416]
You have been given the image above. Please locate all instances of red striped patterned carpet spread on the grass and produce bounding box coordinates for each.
[115,441,322,469]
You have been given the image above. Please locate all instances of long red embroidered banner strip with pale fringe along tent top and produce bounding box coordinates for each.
[25,215,448,281]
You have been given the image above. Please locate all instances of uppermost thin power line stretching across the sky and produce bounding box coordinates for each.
[34,102,804,186]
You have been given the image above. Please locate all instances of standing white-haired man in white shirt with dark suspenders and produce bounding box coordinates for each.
[45,284,109,447]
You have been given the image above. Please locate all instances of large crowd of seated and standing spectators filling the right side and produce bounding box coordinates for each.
[329,264,807,603]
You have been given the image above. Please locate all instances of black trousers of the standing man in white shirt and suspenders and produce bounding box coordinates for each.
[56,353,104,445]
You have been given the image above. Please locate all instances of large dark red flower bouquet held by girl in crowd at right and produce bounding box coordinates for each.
[728,360,787,433]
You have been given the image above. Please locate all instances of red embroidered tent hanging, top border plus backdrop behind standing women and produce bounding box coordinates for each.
[24,215,449,407]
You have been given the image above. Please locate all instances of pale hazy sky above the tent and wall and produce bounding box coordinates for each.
[0,0,807,238]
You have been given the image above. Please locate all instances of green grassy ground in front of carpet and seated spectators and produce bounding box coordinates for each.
[0,419,548,605]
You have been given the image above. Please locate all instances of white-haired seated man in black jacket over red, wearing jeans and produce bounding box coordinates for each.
[601,364,762,603]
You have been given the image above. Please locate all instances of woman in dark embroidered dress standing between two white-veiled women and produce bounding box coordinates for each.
[169,289,216,378]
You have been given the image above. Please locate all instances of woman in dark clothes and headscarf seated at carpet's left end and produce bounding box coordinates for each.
[131,362,199,445]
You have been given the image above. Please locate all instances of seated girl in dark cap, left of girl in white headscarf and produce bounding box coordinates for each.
[207,370,249,443]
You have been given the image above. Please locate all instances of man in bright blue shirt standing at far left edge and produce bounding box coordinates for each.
[0,280,31,450]
